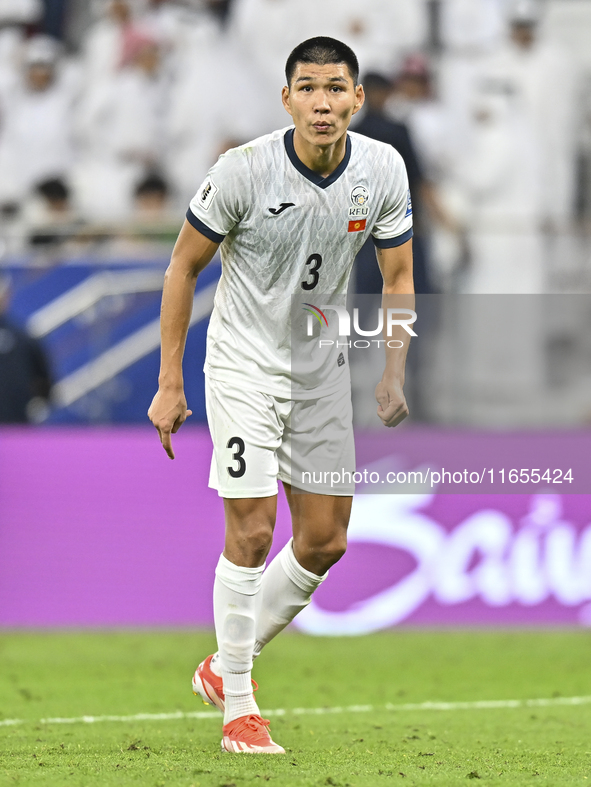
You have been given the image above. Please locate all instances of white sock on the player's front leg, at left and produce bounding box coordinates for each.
[213,555,265,724]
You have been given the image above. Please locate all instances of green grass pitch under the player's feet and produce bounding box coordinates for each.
[0,631,591,787]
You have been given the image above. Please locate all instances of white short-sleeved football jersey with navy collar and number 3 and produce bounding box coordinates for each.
[187,127,412,399]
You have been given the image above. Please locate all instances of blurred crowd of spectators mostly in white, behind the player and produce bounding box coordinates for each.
[0,0,591,292]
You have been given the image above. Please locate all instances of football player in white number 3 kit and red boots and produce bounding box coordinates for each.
[148,37,413,753]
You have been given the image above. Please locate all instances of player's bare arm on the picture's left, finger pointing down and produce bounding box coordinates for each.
[148,220,219,459]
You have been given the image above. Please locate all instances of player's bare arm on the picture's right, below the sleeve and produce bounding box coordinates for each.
[376,240,415,426]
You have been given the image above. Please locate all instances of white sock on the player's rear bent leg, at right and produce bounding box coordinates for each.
[253,538,328,658]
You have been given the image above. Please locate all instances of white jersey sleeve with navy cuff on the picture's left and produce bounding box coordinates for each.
[187,148,250,243]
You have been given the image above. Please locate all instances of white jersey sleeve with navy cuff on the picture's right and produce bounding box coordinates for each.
[371,148,412,249]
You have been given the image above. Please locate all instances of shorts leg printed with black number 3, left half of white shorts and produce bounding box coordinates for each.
[205,378,284,499]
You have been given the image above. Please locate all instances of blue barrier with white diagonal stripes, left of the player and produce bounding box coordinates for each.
[2,258,220,424]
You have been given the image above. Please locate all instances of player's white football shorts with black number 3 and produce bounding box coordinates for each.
[205,375,355,498]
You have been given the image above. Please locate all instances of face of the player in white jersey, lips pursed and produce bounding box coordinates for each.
[282,63,364,146]
